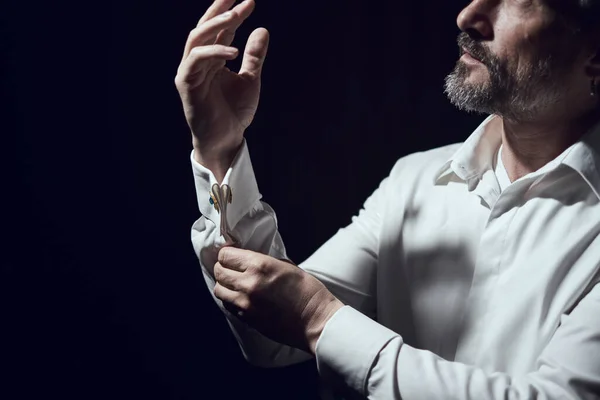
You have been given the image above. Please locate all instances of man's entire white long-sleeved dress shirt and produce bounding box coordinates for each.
[192,116,600,400]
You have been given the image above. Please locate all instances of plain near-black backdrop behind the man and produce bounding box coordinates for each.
[0,0,481,399]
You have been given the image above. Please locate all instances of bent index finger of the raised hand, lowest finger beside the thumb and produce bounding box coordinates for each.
[178,45,238,83]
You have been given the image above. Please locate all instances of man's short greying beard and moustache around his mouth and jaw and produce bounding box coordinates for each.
[445,32,572,121]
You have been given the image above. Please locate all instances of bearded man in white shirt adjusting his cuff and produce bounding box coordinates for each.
[175,0,600,400]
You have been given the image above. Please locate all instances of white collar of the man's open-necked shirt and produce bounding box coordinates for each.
[434,115,600,199]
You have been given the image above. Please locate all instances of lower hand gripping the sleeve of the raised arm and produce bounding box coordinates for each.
[214,247,344,354]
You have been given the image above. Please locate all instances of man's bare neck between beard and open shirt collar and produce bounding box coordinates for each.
[499,111,598,182]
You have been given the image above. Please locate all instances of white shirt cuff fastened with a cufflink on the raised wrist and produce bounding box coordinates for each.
[190,139,262,230]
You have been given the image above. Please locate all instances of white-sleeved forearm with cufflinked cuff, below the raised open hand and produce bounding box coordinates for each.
[192,142,311,367]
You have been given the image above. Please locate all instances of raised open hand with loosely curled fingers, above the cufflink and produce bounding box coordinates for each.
[175,0,269,182]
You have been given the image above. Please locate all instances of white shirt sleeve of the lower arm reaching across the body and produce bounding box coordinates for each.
[316,284,600,400]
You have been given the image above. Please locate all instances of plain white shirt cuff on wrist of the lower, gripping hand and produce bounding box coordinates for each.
[316,306,400,396]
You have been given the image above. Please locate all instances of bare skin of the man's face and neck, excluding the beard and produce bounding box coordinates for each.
[457,0,600,181]
